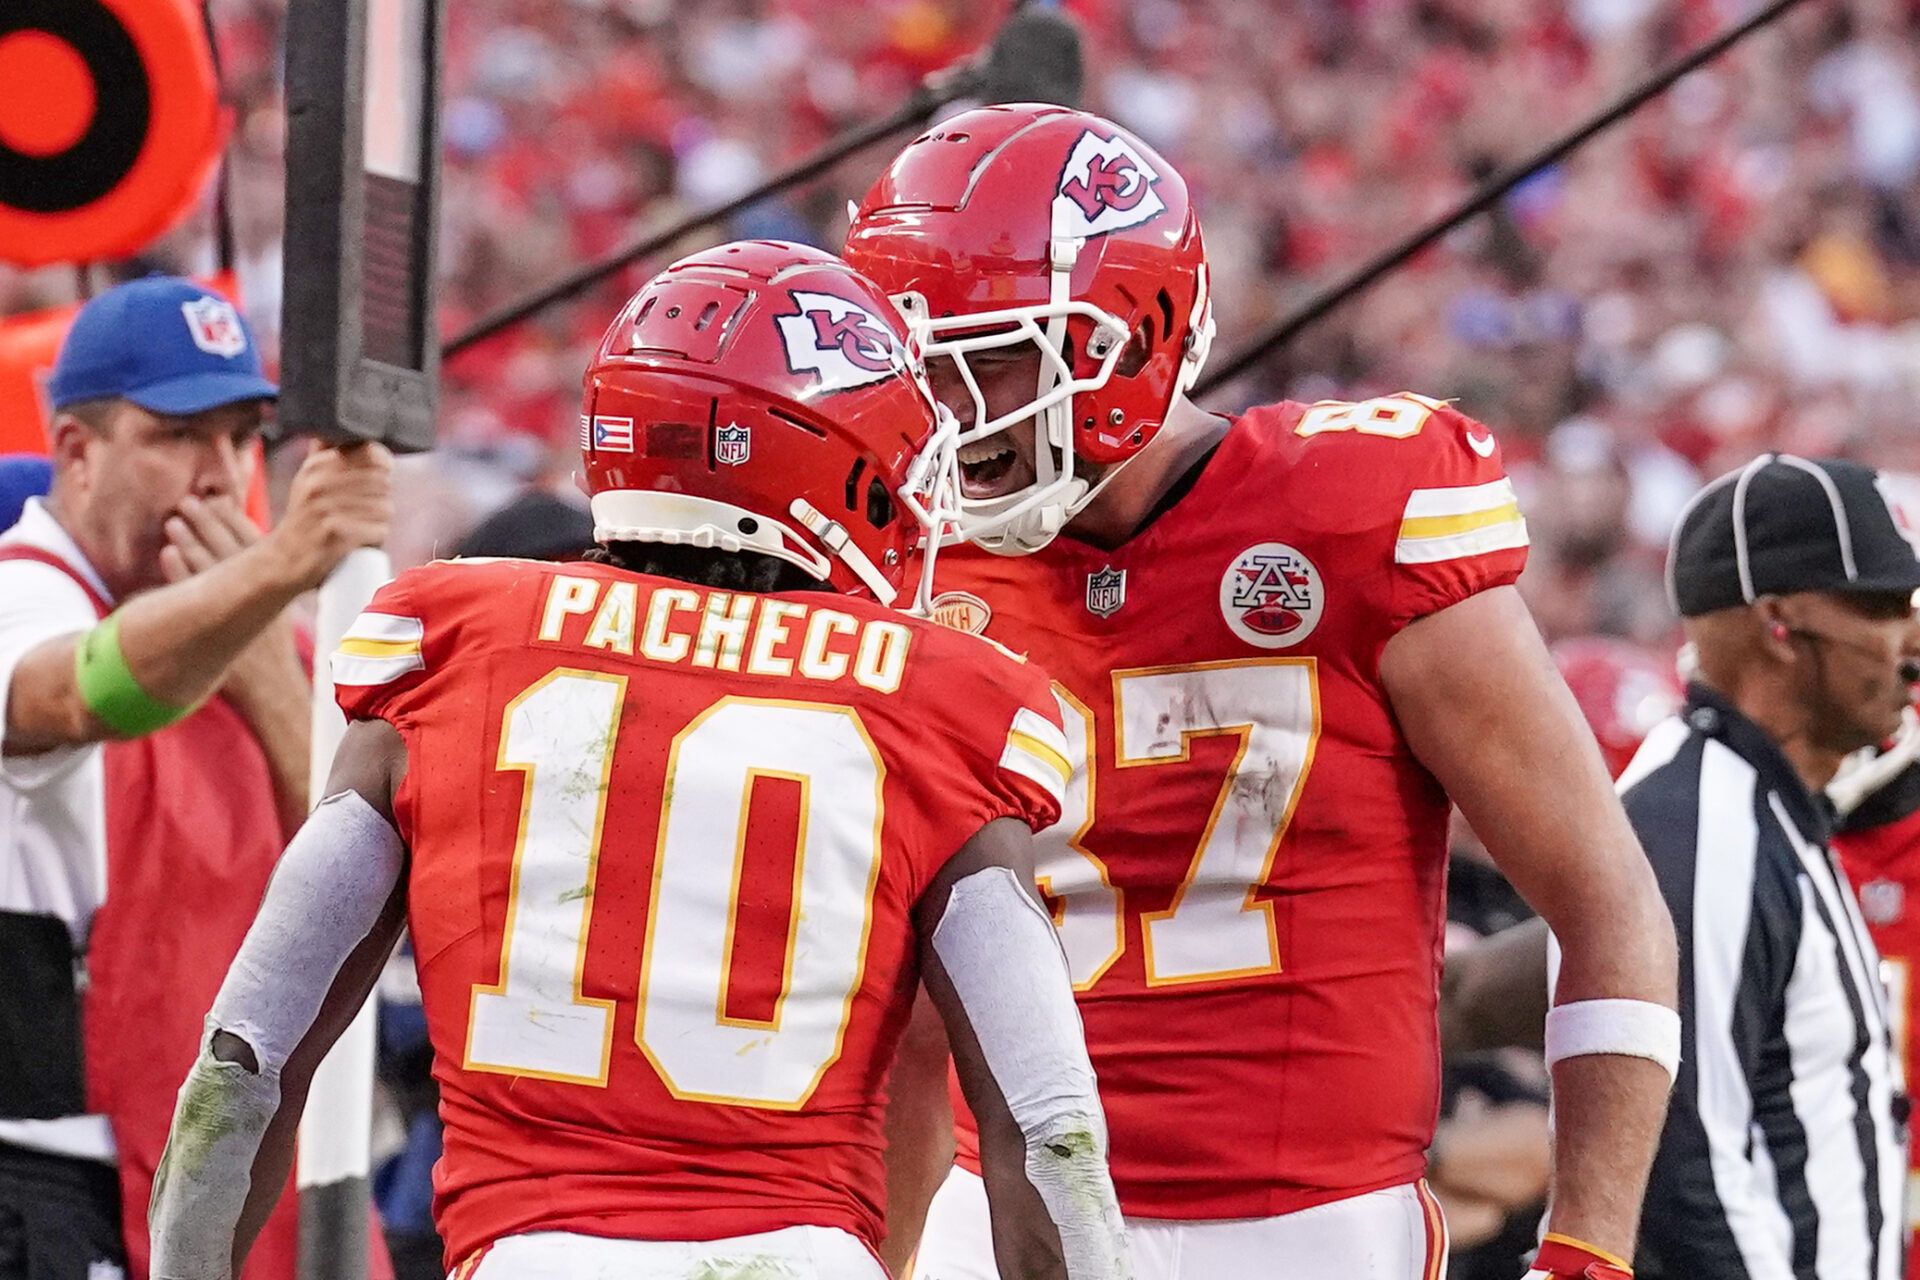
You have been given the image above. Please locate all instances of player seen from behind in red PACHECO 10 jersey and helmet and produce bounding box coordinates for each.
[154,242,1129,1280]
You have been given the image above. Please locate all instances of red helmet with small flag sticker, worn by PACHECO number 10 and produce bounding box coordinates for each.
[580,240,960,604]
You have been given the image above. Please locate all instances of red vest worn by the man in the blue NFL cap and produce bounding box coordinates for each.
[0,547,392,1280]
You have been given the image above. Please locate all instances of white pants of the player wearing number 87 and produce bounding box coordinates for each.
[910,1167,1446,1280]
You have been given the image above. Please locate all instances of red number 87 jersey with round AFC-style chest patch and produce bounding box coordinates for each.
[937,395,1526,1219]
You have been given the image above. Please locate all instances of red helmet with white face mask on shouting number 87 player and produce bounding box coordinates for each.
[847,104,1213,555]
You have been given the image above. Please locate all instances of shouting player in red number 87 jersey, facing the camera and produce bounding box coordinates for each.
[847,106,1680,1280]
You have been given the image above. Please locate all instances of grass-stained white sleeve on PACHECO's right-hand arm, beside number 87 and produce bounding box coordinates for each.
[933,867,1133,1280]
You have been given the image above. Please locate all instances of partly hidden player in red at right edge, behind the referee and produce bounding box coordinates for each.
[1826,712,1920,1276]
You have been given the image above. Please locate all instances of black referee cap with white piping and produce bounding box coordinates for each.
[1667,453,1920,618]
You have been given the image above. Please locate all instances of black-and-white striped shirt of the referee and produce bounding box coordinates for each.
[1620,685,1907,1280]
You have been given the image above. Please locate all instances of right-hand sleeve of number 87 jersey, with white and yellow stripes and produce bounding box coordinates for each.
[1390,397,1526,629]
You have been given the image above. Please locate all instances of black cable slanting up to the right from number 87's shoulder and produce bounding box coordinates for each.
[1194,0,1801,397]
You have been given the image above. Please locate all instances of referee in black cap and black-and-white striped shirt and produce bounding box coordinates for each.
[1620,453,1920,1280]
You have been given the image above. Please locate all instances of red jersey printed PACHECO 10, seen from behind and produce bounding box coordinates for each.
[334,560,1068,1259]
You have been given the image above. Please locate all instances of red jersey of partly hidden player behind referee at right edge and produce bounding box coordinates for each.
[1834,764,1920,1276]
